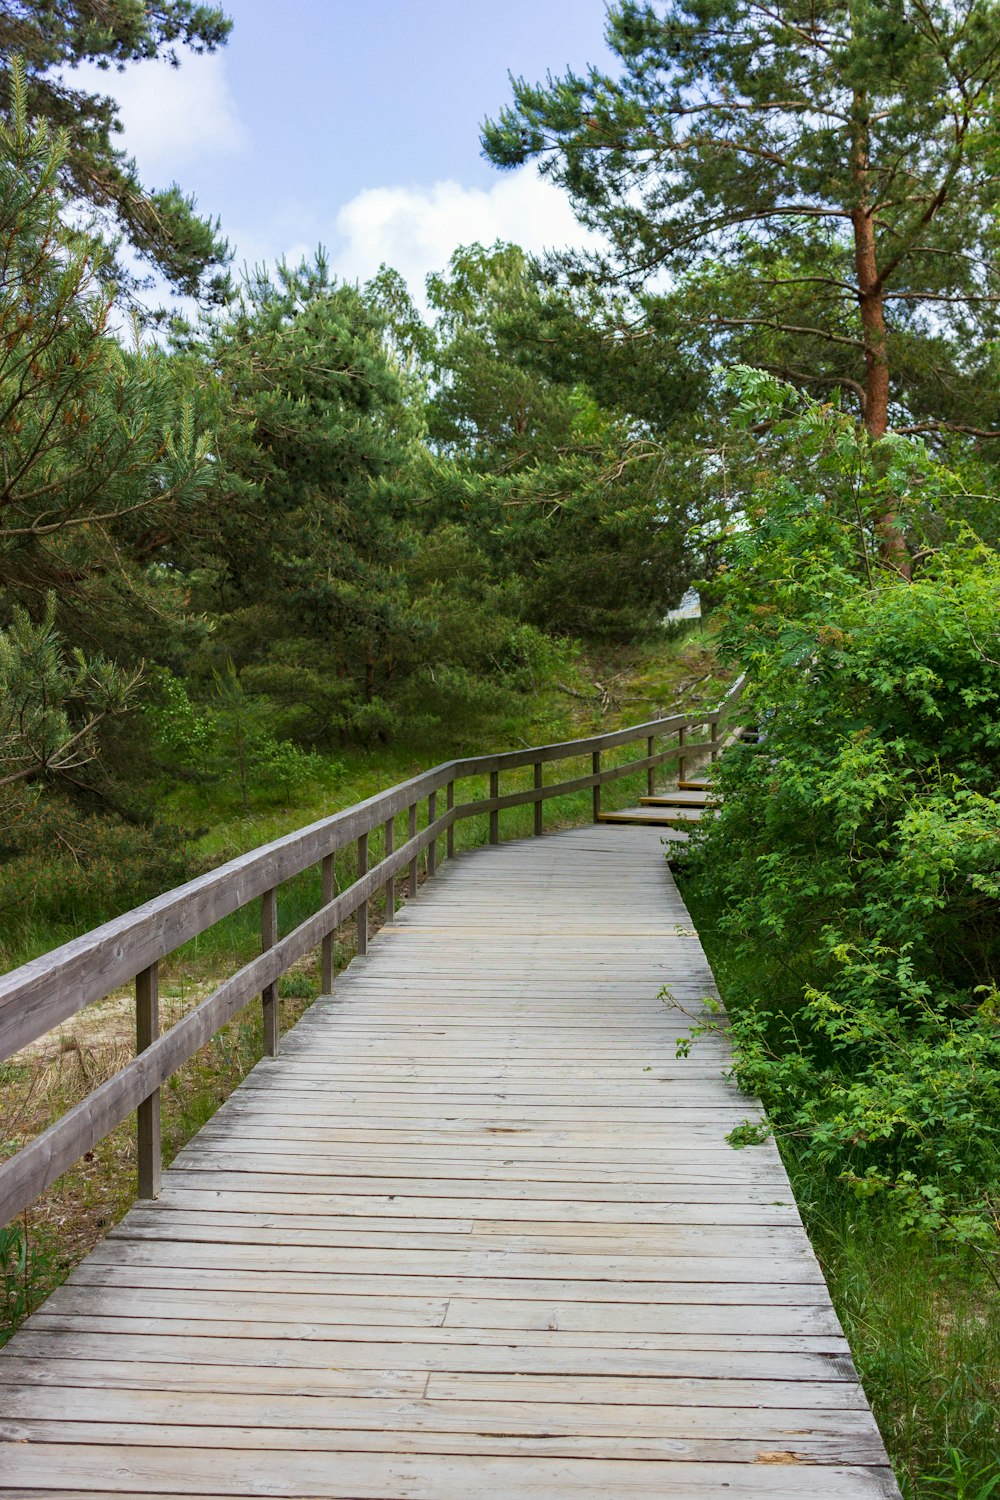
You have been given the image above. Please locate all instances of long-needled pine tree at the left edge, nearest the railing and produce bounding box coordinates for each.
[0,57,210,654]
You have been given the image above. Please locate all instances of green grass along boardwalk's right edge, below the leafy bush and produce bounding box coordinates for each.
[684,876,1000,1500]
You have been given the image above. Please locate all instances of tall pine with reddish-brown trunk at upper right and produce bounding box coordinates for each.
[484,0,1000,570]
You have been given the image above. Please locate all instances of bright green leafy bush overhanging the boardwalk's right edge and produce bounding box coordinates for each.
[680,377,1000,1239]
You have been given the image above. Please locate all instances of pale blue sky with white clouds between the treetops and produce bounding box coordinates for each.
[76,0,612,307]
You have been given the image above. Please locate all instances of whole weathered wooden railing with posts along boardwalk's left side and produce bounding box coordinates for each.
[0,678,742,1226]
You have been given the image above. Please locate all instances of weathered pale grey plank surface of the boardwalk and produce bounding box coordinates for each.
[0,827,897,1500]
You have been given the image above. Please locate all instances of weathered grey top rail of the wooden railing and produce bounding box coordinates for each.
[0,677,744,1061]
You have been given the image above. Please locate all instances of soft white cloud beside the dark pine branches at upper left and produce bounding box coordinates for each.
[67,53,247,186]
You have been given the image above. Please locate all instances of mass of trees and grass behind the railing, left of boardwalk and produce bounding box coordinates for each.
[0,43,719,963]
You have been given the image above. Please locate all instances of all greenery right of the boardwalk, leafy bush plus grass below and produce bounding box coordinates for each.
[671,381,1000,1497]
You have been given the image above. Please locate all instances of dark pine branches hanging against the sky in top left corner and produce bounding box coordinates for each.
[0,0,232,297]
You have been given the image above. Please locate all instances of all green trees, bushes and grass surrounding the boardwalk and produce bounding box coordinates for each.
[0,0,1000,1500]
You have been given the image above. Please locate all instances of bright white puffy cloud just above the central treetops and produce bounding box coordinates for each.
[328,167,594,303]
